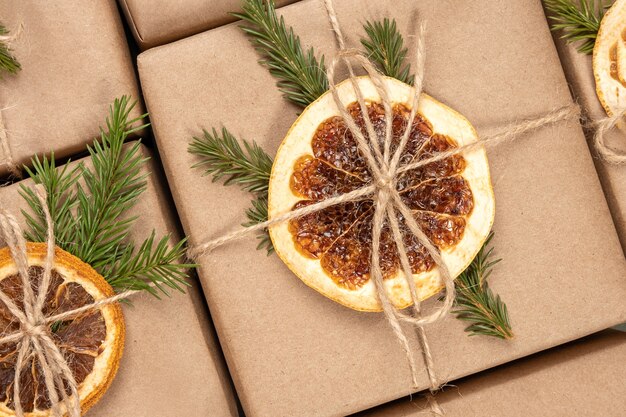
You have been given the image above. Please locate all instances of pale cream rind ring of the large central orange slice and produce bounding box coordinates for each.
[268,77,495,311]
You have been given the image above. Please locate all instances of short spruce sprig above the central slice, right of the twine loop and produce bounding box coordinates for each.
[361,18,414,84]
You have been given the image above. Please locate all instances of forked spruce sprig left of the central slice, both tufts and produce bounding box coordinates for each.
[188,128,273,254]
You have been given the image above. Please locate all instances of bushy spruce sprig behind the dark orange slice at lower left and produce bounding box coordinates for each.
[20,96,195,296]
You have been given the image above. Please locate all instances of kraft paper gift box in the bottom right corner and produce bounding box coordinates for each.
[355,330,626,417]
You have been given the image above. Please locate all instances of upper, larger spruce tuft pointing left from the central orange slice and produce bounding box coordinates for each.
[189,128,272,193]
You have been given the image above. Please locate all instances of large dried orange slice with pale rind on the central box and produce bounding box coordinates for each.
[268,77,495,311]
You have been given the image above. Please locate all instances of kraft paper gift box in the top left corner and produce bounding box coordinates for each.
[0,0,141,177]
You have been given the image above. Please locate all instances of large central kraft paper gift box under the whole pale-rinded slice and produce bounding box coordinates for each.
[138,0,626,416]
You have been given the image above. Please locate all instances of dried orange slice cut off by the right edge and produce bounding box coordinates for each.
[593,0,626,121]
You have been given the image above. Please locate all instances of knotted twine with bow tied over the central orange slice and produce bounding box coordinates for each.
[188,0,580,415]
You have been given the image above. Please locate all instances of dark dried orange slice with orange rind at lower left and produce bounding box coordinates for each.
[0,243,125,417]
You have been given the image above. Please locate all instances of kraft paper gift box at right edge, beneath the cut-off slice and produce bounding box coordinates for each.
[548,2,626,254]
